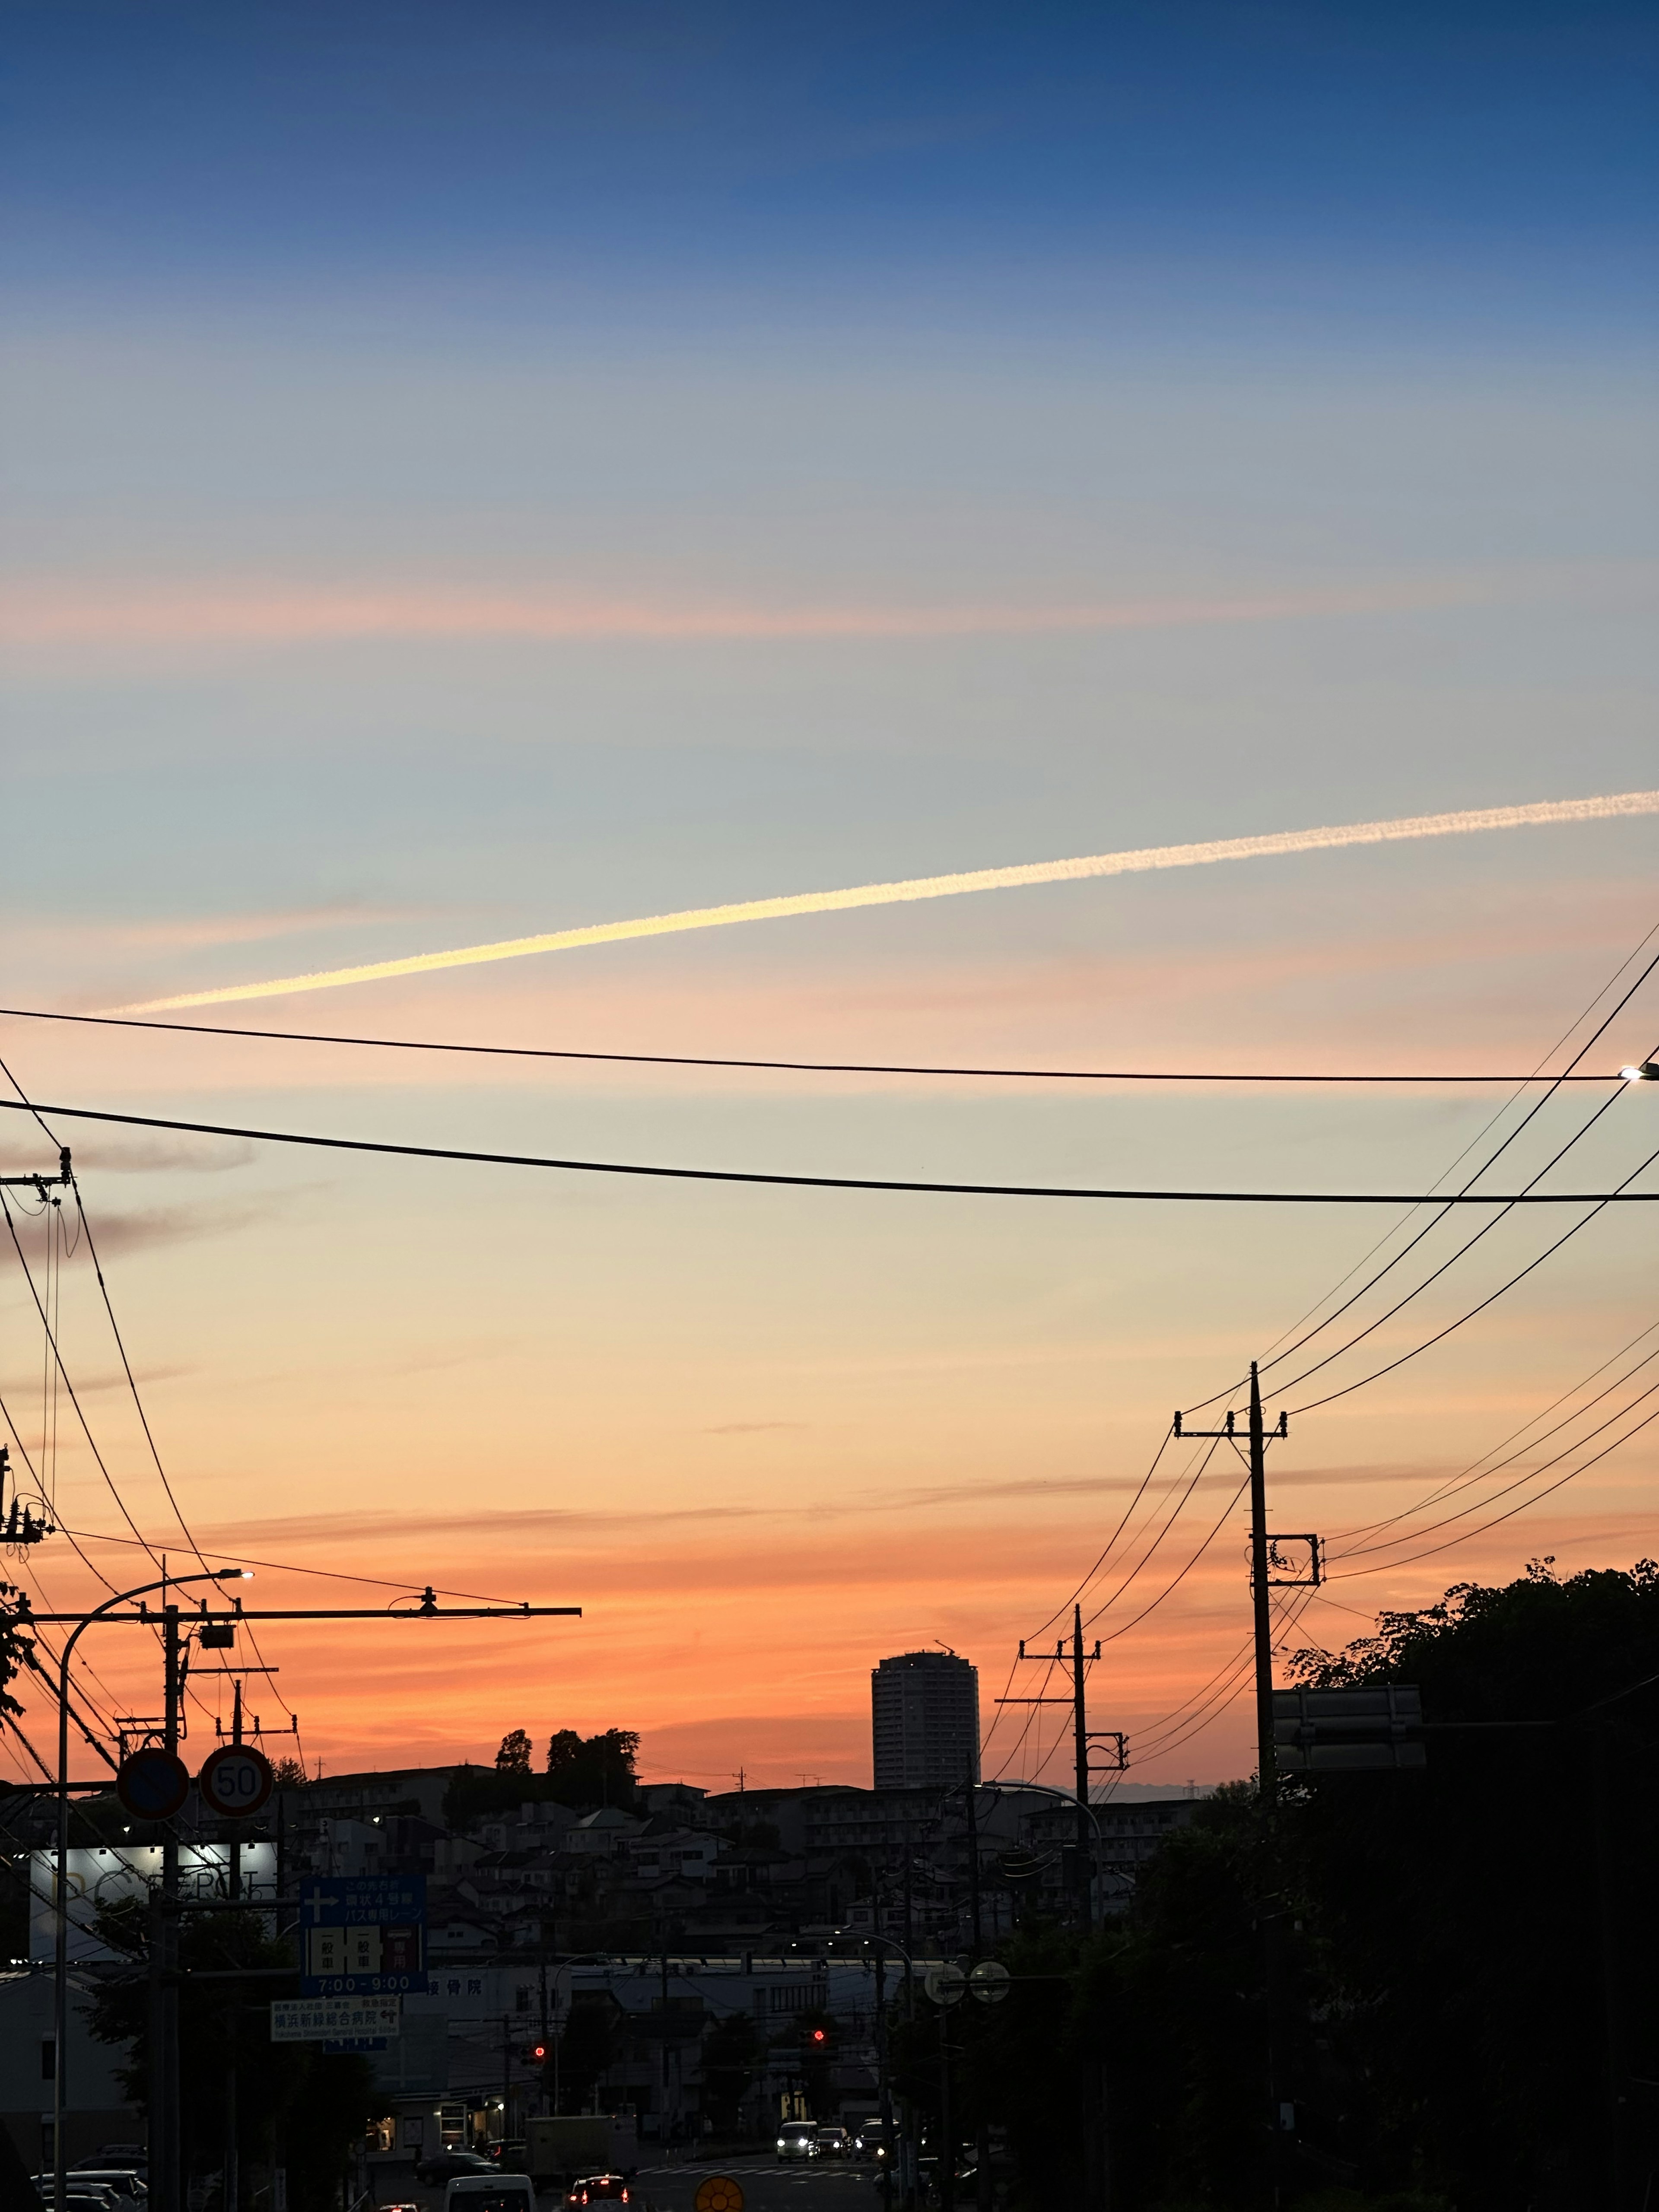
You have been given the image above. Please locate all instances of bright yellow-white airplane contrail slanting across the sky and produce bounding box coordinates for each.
[104,792,1659,1013]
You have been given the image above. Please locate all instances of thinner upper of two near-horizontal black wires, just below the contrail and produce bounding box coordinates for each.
[0,1007,1621,1084]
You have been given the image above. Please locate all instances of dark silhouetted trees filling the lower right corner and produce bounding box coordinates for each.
[911,1562,1659,2212]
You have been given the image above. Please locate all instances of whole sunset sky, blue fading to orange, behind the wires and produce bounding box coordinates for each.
[0,0,1659,1787]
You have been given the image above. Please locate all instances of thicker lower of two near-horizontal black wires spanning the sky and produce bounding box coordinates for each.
[0,1100,1659,1205]
